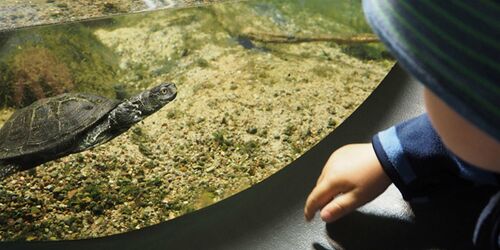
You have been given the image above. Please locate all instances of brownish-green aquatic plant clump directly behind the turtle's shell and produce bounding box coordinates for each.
[0,24,118,107]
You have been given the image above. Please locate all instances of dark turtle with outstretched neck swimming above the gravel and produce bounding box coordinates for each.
[0,83,177,180]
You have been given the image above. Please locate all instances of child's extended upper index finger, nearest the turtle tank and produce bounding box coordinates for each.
[304,180,346,220]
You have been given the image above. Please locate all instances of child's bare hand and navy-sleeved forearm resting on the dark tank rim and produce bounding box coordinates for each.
[304,114,500,222]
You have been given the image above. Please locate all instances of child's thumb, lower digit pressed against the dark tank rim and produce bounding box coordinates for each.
[320,192,359,222]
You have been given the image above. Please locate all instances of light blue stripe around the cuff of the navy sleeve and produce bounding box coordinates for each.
[378,127,416,184]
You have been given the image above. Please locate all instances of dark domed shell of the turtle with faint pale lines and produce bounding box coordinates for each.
[0,94,119,160]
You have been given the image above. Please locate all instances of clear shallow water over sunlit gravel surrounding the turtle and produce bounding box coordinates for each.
[0,0,394,240]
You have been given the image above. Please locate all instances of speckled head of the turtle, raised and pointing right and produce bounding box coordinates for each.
[139,83,177,114]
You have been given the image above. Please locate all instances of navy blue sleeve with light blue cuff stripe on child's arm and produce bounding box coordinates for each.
[372,114,499,200]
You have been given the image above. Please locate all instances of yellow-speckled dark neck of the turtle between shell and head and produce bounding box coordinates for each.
[108,101,144,128]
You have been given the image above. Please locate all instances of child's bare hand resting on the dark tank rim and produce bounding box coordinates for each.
[304,143,391,222]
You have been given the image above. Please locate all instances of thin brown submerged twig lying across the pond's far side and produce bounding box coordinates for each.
[240,32,380,44]
